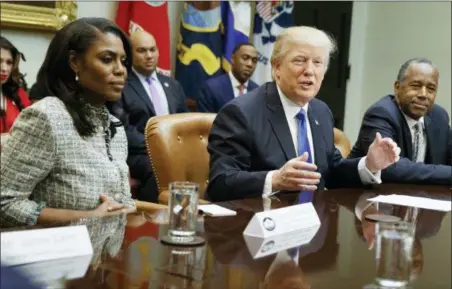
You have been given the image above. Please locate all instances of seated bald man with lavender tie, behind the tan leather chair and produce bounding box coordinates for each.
[121,31,188,202]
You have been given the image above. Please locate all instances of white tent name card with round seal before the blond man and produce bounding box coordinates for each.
[243,203,320,239]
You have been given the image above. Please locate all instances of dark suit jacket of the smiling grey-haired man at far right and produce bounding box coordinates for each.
[349,95,452,185]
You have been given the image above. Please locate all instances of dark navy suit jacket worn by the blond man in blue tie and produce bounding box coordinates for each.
[207,82,361,201]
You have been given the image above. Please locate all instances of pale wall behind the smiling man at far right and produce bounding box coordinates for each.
[345,2,452,143]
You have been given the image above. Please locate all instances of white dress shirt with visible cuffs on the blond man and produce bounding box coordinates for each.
[262,86,381,197]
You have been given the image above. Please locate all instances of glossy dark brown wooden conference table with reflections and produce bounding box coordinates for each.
[7,184,452,289]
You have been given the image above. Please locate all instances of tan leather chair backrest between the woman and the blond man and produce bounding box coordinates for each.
[145,112,216,198]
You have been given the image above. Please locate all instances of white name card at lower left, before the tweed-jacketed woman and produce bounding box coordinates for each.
[0,226,93,266]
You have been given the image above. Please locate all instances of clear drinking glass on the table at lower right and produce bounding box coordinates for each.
[375,222,415,288]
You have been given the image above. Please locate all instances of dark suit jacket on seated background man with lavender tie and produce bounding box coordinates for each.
[120,72,188,176]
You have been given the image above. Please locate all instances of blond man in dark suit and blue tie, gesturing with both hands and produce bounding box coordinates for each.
[207,26,399,201]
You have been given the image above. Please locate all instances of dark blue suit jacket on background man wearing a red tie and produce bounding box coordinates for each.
[196,73,258,113]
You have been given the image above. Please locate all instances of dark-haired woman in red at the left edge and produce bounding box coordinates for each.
[0,36,31,134]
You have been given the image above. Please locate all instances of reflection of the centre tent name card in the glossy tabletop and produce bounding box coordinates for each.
[244,224,320,259]
